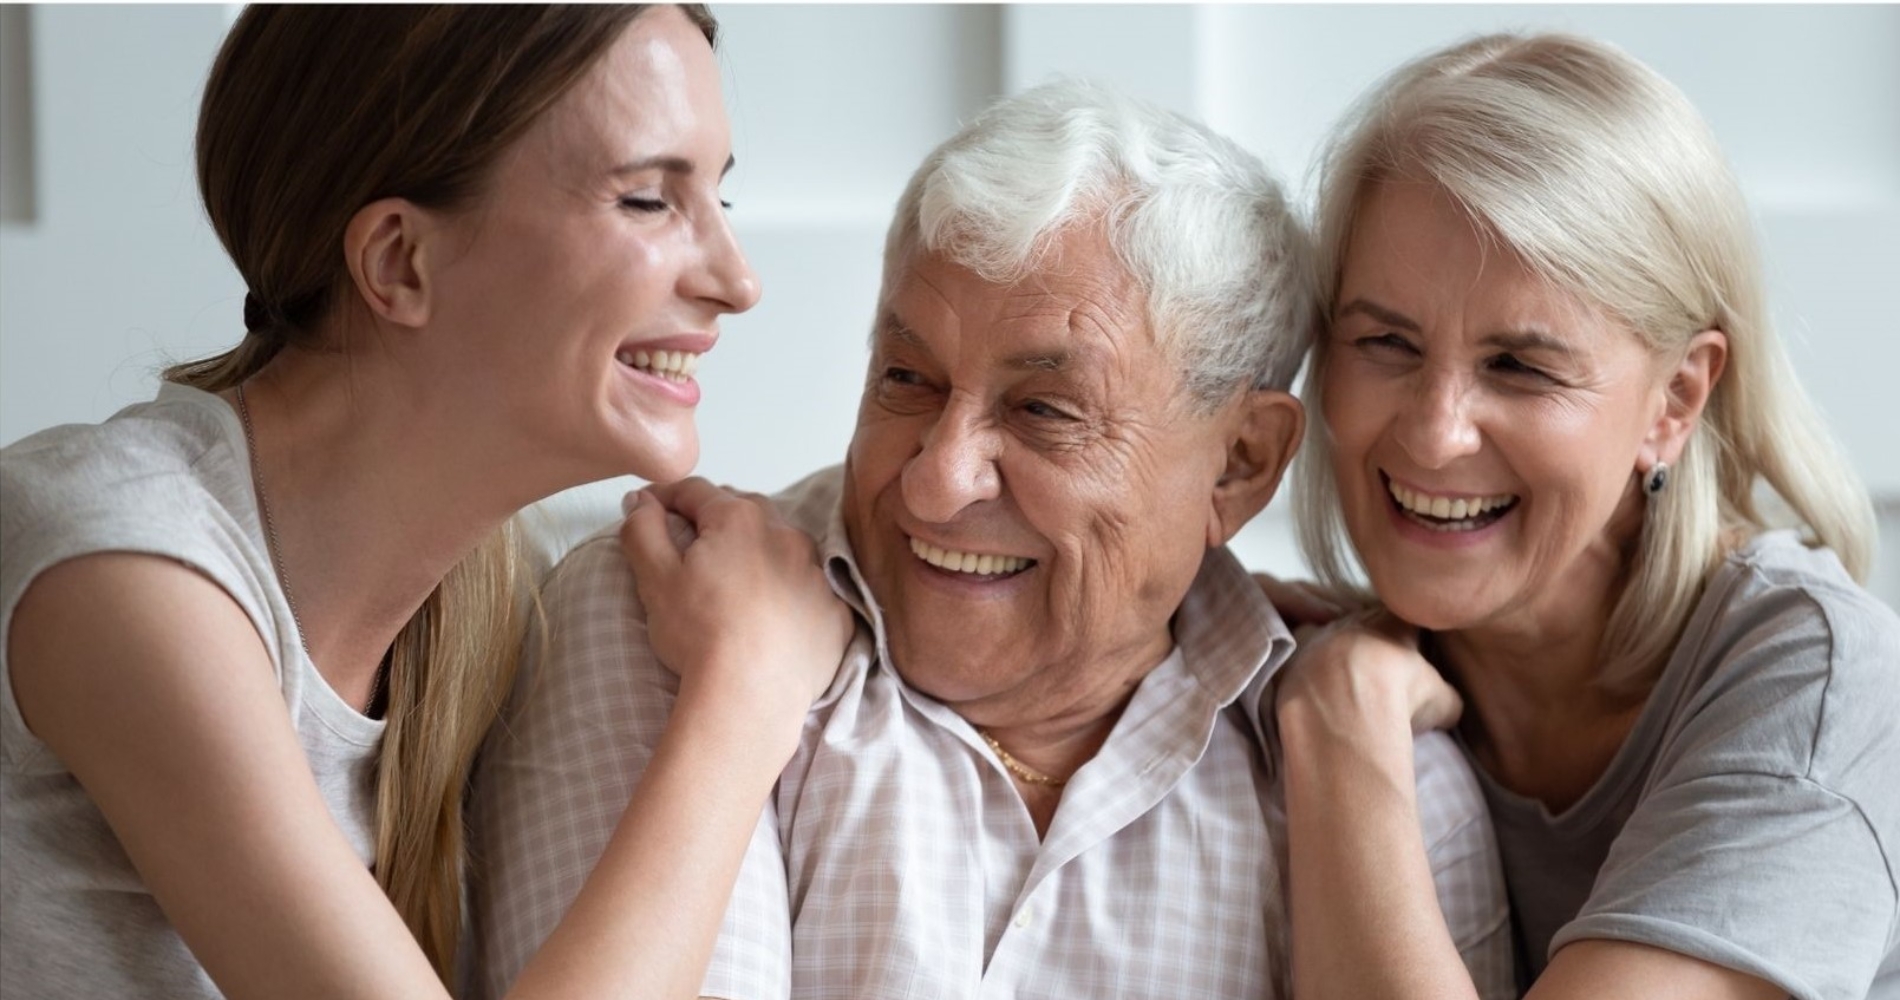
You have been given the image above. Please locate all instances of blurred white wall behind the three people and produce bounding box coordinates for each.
[0,6,1900,605]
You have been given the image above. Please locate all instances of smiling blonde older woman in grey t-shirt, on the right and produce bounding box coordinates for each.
[1277,36,1900,1000]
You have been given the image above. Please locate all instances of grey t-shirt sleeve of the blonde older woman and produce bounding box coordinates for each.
[1550,587,1900,1000]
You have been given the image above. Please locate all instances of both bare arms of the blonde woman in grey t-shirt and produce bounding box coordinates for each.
[1279,629,1782,1000]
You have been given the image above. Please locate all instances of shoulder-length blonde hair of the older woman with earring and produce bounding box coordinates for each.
[1294,34,1873,686]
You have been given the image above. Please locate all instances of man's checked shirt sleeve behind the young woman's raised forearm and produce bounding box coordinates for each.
[469,538,790,1000]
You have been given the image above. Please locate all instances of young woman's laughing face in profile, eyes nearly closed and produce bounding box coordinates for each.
[431,8,758,483]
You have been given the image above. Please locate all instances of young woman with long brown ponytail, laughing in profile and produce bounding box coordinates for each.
[0,6,849,998]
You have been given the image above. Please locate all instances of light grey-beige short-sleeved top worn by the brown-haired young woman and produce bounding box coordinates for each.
[0,384,382,1000]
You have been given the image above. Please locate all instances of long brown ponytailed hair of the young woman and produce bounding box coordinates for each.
[165,4,716,981]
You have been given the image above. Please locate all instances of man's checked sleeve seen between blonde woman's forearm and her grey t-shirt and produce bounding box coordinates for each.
[1412,732,1516,1000]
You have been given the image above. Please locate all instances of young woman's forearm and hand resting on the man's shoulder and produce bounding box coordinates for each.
[509,479,851,996]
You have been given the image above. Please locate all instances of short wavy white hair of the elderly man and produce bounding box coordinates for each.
[884,80,1315,407]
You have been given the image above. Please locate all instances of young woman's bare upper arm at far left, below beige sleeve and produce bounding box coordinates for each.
[8,553,445,998]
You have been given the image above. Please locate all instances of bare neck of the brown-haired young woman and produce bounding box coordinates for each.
[226,350,551,703]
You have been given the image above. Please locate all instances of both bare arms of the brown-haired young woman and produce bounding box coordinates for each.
[10,484,849,998]
